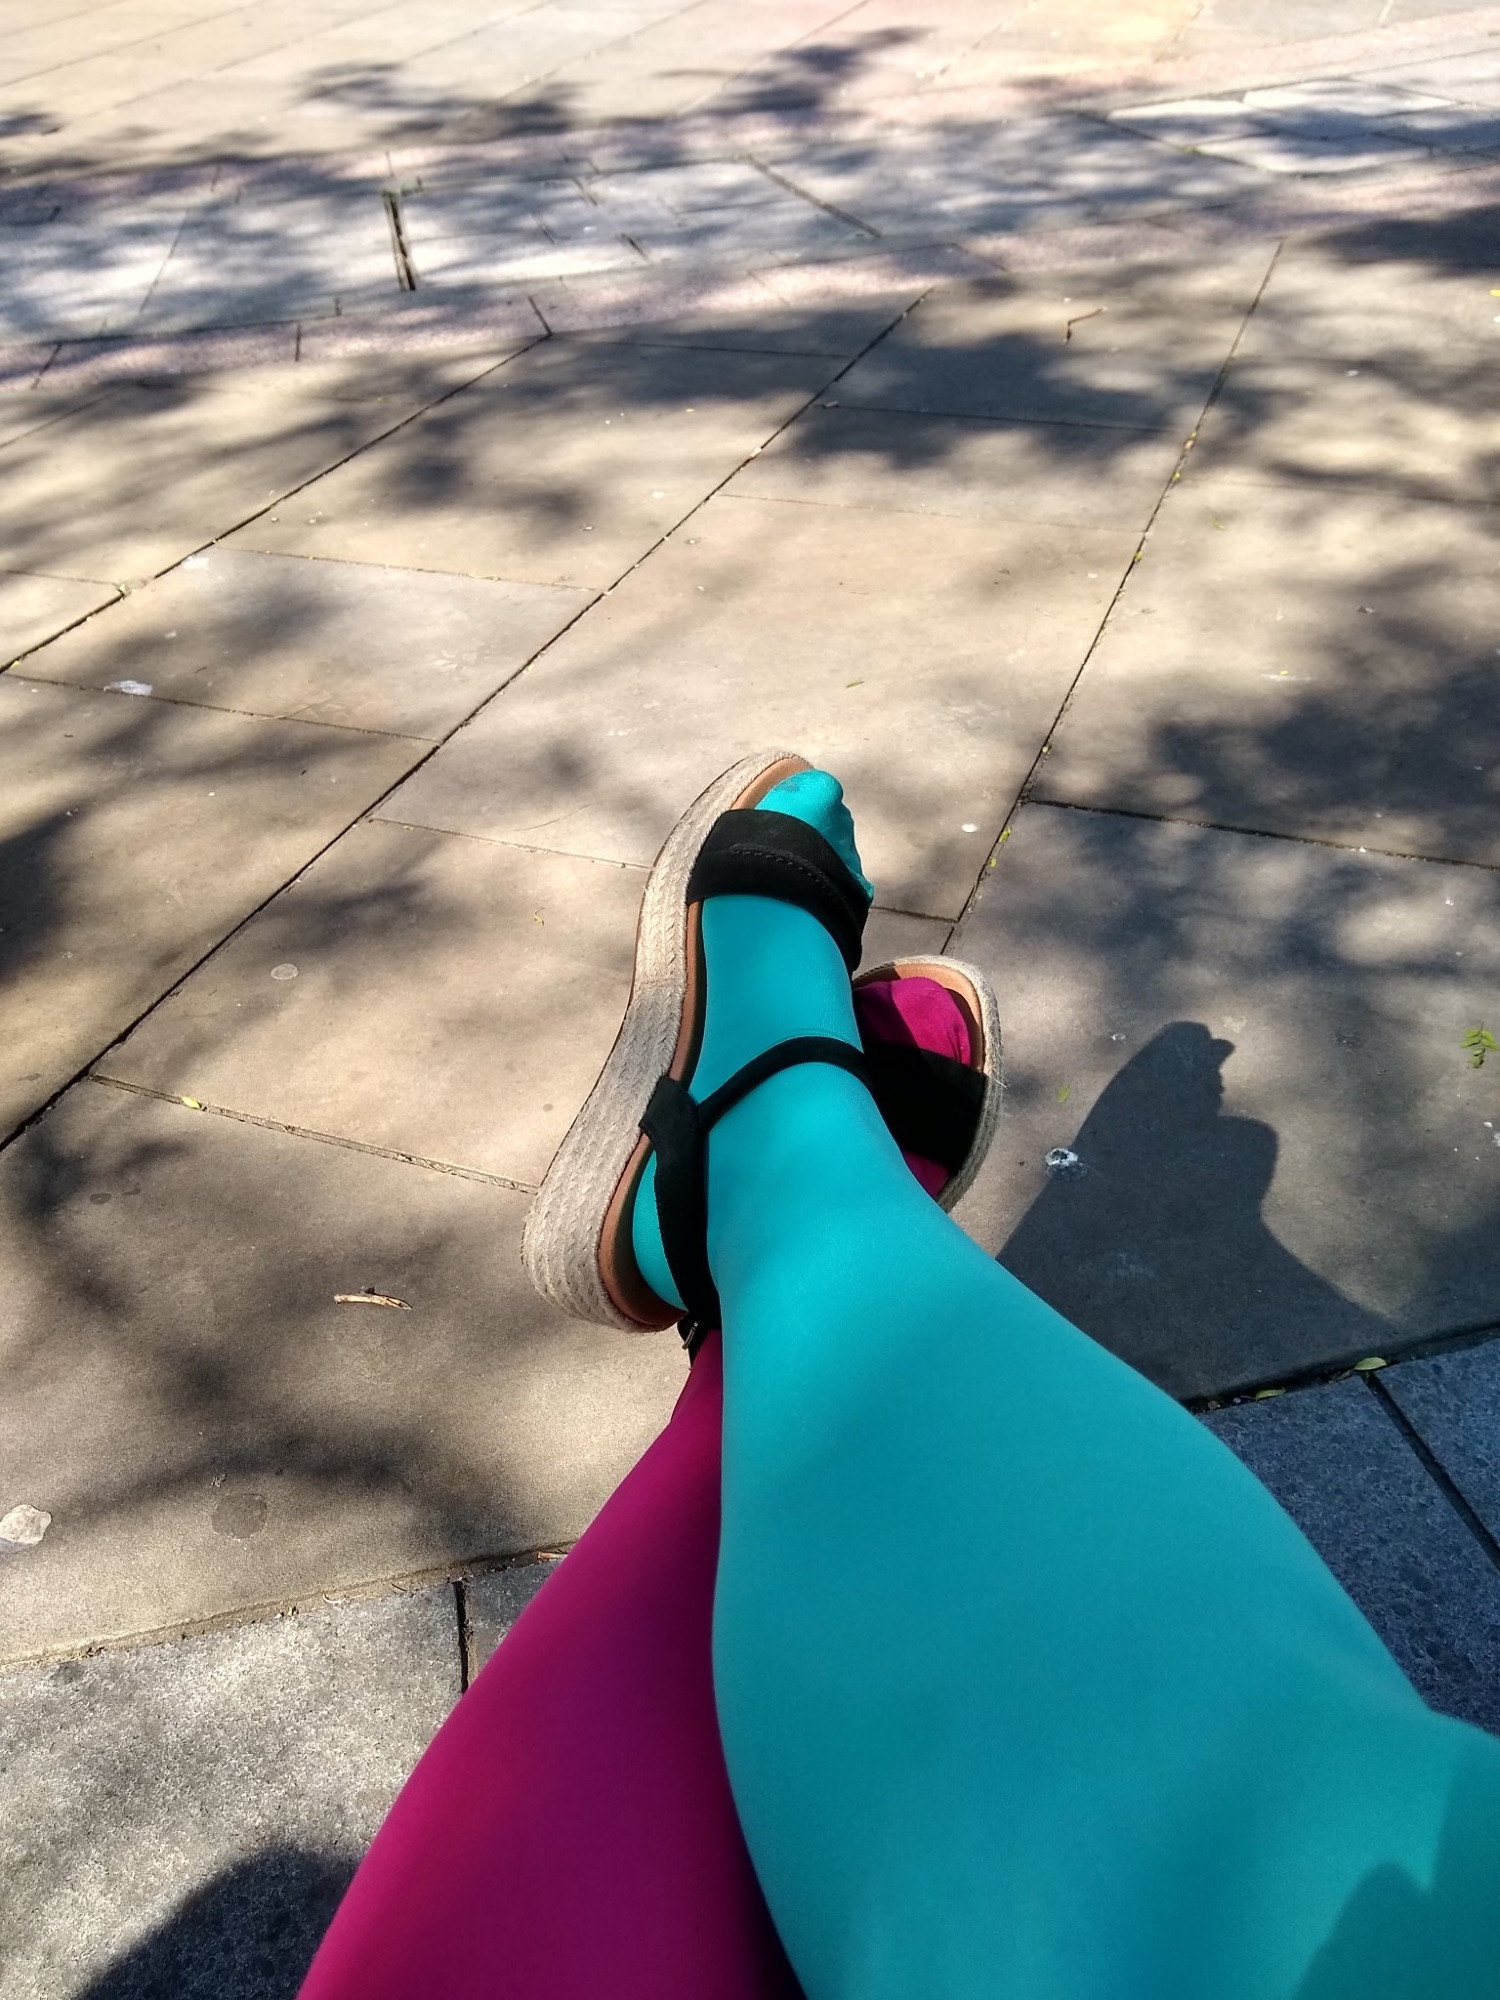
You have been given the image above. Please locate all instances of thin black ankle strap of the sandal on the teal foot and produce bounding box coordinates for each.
[640,1034,870,1352]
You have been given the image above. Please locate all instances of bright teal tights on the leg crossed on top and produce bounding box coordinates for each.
[636,780,1500,2000]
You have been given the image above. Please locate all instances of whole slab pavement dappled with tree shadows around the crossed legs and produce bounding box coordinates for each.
[0,0,1500,2000]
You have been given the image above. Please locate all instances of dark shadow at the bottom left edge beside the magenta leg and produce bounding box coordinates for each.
[78,1848,354,2000]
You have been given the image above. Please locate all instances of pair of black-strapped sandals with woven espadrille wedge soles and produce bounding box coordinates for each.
[524,752,1000,1346]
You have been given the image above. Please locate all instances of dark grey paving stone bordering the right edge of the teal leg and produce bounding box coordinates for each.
[1204,1378,1500,1730]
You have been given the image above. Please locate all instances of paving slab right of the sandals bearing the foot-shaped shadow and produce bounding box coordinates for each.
[952,806,1500,1396]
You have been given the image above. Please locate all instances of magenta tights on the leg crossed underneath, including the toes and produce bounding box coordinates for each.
[302,978,970,2000]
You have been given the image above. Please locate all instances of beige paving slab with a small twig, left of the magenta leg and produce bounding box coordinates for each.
[0,1082,684,1660]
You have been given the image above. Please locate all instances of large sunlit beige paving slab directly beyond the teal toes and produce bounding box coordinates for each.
[370,496,1136,916]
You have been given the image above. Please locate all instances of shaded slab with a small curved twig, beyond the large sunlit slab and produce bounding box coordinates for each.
[838,258,1264,438]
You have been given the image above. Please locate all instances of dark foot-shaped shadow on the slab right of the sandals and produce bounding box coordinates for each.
[1000,1020,1386,1396]
